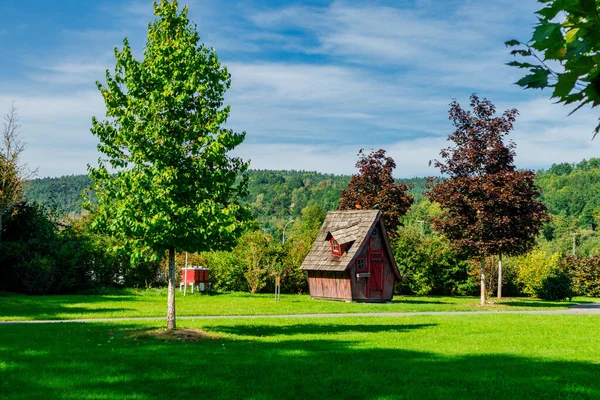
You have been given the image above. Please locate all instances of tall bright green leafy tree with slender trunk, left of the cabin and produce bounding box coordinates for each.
[88,0,248,329]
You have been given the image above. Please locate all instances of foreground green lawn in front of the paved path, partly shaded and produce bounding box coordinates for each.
[0,313,600,400]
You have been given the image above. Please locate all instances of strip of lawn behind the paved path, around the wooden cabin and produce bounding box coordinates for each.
[0,289,597,321]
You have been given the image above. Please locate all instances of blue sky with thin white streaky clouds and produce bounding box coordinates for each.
[0,0,600,177]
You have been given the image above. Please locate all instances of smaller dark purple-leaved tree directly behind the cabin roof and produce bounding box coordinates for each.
[339,149,413,235]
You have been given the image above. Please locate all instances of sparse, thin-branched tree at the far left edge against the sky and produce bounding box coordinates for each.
[0,106,27,240]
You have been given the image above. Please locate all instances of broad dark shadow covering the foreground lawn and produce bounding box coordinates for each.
[0,323,600,400]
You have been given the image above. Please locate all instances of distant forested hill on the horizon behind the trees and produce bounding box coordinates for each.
[27,158,600,229]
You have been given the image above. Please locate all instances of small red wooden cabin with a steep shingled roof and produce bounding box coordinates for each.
[301,210,400,302]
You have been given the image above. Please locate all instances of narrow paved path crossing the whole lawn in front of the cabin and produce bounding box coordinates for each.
[0,303,600,325]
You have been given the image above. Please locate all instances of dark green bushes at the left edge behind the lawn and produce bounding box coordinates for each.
[0,202,157,294]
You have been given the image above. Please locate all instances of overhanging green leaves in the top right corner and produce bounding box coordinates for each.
[506,0,600,136]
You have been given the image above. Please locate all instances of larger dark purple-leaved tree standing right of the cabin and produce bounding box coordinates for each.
[426,94,548,305]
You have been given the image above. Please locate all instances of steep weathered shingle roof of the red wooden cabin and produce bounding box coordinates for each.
[300,210,397,271]
